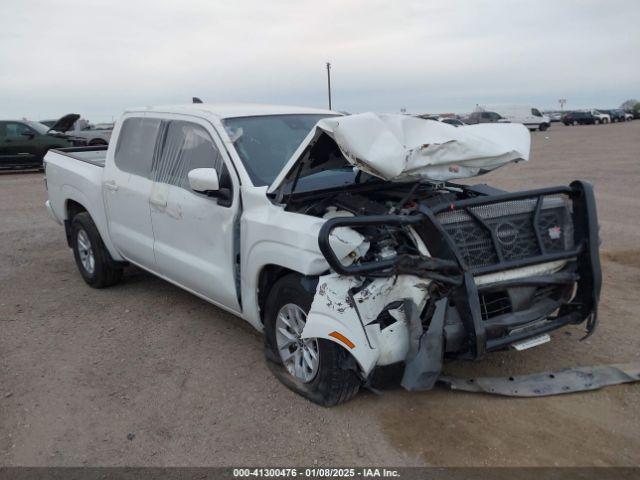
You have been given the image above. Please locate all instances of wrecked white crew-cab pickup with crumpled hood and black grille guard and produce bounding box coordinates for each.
[45,104,601,405]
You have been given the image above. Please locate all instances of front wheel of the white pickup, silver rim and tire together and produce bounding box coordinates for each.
[264,274,361,407]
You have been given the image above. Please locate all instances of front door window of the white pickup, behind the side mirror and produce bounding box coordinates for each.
[154,121,223,191]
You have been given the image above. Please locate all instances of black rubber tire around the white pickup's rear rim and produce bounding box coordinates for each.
[71,212,122,288]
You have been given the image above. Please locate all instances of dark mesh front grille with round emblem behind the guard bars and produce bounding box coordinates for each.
[437,195,574,270]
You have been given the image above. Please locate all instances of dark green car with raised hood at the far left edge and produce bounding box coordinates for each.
[0,120,74,169]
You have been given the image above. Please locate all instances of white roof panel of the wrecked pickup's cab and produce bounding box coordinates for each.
[127,103,337,118]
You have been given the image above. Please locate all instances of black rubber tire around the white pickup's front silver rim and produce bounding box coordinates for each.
[264,274,361,407]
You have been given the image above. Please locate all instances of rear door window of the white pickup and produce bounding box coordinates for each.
[115,118,160,177]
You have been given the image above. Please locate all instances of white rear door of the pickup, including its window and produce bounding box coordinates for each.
[102,113,161,271]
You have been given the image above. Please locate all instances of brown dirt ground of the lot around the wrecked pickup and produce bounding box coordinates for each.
[0,121,640,466]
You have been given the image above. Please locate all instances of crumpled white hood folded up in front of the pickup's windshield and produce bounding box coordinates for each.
[269,113,531,193]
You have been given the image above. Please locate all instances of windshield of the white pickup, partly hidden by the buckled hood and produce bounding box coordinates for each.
[223,114,335,186]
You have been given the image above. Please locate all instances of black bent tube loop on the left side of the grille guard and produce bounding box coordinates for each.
[318,214,461,285]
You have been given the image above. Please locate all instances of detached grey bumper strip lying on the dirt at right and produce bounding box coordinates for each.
[438,362,640,397]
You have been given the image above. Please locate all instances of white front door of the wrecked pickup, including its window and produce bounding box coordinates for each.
[150,119,240,312]
